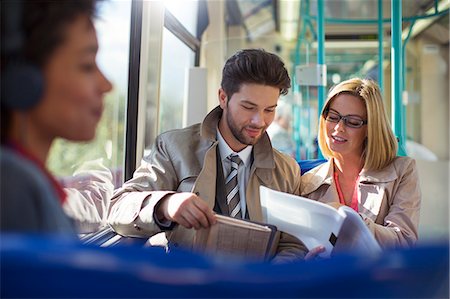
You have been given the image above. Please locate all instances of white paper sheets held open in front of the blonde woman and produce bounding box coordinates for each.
[260,186,381,257]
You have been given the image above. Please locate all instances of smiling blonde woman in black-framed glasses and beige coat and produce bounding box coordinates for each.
[302,78,421,248]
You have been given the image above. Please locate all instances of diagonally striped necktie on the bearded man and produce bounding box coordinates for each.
[225,154,242,218]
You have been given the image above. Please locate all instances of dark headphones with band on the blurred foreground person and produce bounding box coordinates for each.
[0,0,44,111]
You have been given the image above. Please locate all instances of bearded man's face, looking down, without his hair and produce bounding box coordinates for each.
[219,84,280,152]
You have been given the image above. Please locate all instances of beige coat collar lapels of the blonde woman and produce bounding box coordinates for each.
[302,158,398,195]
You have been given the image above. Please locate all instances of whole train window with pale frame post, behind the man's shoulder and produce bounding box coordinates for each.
[139,0,200,161]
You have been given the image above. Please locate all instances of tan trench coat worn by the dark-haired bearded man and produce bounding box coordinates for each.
[109,107,307,261]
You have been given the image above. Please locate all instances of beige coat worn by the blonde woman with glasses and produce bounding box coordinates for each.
[301,157,421,248]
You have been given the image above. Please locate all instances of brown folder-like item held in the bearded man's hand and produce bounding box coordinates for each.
[194,215,278,261]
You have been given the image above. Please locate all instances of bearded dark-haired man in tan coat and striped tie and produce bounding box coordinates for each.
[109,49,307,262]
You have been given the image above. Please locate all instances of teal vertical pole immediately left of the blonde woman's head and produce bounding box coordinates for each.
[317,0,325,158]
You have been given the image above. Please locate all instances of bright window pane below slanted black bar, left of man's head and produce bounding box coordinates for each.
[158,28,195,133]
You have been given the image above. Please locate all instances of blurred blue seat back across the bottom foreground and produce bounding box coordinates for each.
[0,234,449,298]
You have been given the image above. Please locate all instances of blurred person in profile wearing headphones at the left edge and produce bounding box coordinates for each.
[0,0,111,235]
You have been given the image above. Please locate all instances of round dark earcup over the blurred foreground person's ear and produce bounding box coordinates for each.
[1,63,44,111]
